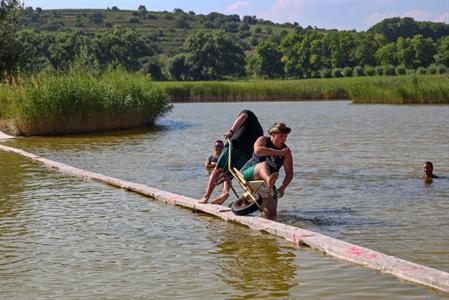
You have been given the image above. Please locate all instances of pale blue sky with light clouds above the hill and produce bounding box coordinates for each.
[23,0,449,31]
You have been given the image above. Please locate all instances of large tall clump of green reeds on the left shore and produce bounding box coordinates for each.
[0,68,171,136]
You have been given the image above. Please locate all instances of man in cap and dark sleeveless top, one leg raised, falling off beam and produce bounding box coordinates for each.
[240,122,293,219]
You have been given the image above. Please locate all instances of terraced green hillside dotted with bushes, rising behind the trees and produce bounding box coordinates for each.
[22,7,302,56]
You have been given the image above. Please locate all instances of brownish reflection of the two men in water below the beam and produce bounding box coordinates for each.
[214,226,297,299]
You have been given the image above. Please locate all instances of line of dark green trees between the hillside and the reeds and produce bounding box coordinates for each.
[0,0,449,80]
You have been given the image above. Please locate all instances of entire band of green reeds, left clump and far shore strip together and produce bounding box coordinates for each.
[0,73,449,136]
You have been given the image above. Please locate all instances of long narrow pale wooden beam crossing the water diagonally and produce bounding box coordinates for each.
[0,144,449,293]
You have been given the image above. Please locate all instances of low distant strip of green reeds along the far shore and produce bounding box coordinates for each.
[157,75,449,104]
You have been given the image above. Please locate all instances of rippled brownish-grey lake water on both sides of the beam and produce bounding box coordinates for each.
[0,101,449,299]
